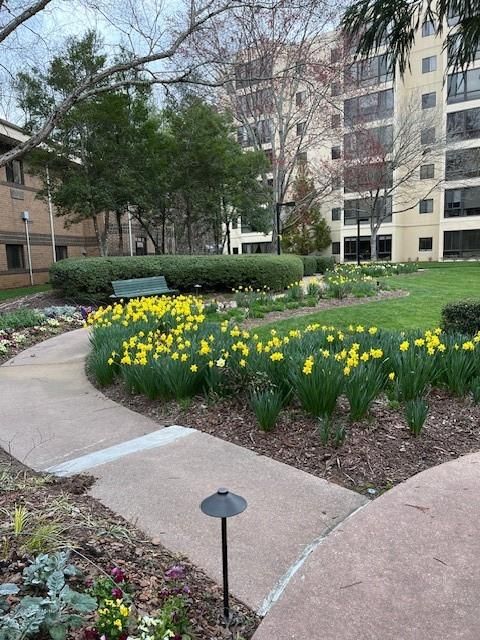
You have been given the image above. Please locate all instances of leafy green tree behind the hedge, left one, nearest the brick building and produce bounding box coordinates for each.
[17,32,156,255]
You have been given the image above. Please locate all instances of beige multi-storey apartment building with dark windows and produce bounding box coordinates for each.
[230,18,480,262]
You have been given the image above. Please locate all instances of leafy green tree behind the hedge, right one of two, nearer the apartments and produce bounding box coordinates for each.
[165,96,266,253]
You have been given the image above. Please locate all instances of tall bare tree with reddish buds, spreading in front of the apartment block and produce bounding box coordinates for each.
[190,0,343,251]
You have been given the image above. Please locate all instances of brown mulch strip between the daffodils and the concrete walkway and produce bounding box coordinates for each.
[102,383,480,497]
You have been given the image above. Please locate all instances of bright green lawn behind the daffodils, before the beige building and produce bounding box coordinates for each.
[259,263,480,333]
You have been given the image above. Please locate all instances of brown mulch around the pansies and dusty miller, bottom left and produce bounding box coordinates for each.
[0,449,259,640]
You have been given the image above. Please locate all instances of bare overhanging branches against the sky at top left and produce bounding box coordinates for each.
[0,0,284,166]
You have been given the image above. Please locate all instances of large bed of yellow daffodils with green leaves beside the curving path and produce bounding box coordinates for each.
[87,296,480,492]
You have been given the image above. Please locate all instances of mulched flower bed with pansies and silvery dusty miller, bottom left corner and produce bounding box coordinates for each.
[0,451,258,640]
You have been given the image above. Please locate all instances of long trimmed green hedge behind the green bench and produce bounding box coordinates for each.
[50,255,303,302]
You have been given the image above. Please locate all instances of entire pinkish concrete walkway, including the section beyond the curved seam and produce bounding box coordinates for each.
[0,330,480,640]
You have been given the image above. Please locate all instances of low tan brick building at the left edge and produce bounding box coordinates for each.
[0,119,98,289]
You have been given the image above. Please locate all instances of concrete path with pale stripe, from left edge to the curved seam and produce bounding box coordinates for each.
[0,330,366,613]
